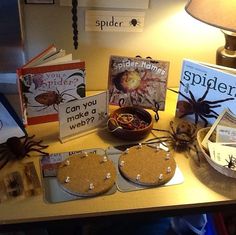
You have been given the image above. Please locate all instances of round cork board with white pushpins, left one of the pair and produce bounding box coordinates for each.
[57,153,116,197]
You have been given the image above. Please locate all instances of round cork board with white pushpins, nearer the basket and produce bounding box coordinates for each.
[119,145,176,186]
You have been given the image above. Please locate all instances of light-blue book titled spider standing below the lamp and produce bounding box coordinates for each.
[176,59,236,126]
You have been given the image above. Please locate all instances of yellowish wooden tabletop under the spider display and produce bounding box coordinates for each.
[0,91,236,224]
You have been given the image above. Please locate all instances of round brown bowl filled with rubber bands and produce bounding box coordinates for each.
[107,106,153,140]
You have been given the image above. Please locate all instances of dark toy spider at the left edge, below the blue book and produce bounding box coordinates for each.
[0,135,48,169]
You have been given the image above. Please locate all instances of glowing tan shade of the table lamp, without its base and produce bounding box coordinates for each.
[185,0,236,32]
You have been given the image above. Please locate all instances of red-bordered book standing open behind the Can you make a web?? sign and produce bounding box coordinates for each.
[17,45,85,125]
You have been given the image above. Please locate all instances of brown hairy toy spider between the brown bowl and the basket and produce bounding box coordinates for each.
[147,121,200,163]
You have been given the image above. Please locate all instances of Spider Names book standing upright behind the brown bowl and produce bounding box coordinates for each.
[108,56,169,110]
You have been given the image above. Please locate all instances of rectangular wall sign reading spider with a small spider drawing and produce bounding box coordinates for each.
[85,10,145,32]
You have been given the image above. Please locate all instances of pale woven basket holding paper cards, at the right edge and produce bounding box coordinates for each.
[197,127,236,178]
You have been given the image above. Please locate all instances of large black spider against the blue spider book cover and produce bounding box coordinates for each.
[171,83,234,127]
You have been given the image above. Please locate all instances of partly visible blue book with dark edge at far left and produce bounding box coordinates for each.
[0,93,26,144]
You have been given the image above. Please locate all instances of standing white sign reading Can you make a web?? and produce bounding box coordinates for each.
[59,91,108,142]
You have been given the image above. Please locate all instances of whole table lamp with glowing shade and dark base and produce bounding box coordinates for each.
[185,0,236,68]
